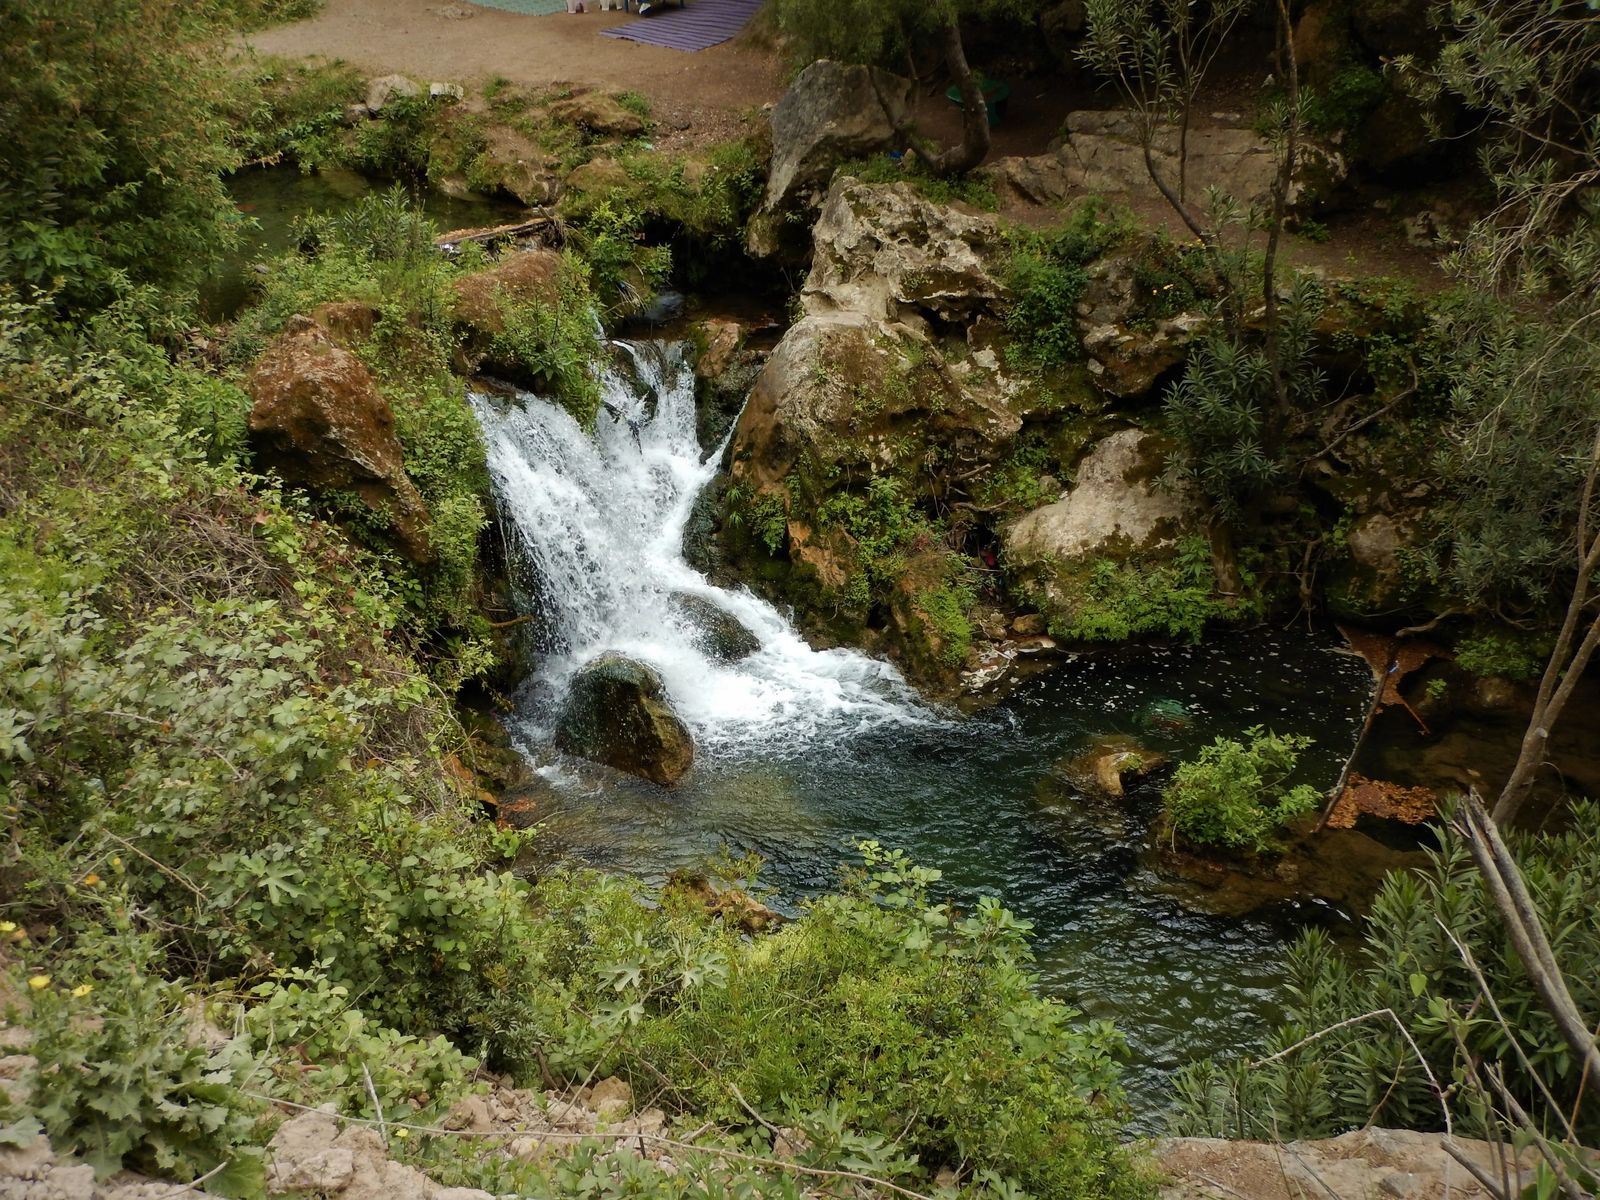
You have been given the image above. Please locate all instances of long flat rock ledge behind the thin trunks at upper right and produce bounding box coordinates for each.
[987,109,1349,213]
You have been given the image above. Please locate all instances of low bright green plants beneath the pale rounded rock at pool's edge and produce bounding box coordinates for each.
[1050,538,1254,642]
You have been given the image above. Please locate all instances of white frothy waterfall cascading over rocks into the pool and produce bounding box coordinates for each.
[469,342,936,758]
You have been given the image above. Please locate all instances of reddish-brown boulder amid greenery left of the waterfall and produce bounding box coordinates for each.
[248,317,432,563]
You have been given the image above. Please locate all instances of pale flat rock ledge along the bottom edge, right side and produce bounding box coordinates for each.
[1150,1128,1533,1200]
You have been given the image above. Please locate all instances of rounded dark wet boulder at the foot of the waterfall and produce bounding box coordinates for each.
[555,654,694,787]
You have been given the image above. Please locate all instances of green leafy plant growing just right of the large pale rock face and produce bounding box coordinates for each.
[1005,200,1126,371]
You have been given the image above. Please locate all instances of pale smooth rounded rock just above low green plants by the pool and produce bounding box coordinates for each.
[1005,429,1198,562]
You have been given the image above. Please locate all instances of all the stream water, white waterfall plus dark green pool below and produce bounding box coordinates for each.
[474,342,1371,1112]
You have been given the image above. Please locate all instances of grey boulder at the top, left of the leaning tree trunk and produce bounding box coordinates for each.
[750,59,910,258]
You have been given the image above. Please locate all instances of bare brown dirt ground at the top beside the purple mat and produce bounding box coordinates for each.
[250,0,784,139]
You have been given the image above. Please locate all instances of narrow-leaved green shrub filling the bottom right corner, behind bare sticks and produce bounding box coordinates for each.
[1176,803,1600,1146]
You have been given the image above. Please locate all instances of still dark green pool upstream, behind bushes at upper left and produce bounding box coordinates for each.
[200,166,526,320]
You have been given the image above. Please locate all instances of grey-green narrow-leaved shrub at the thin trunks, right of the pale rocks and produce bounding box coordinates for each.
[1166,277,1323,520]
